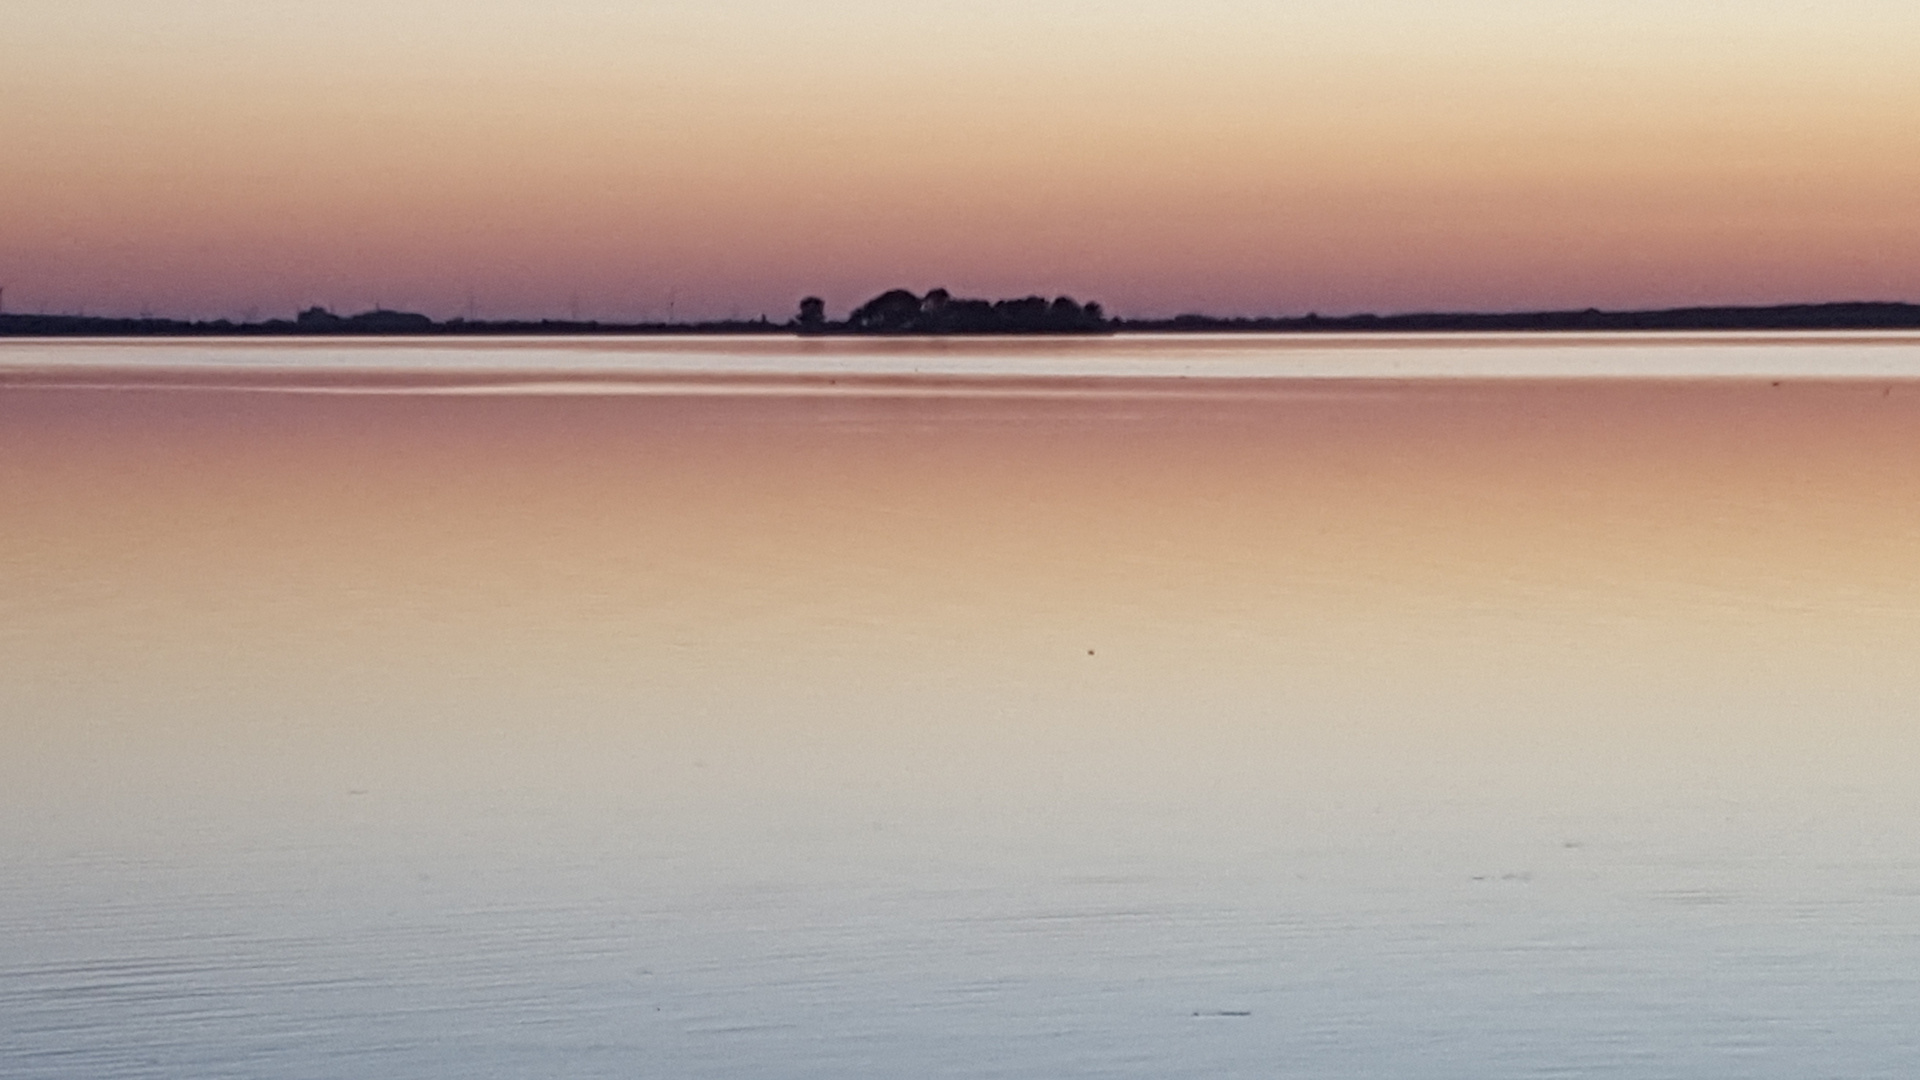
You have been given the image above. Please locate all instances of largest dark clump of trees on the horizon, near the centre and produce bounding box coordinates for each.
[793,288,1112,334]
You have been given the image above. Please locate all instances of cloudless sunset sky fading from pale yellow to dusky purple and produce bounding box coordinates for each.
[0,0,1920,319]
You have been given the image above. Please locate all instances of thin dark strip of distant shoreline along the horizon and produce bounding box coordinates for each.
[0,302,1920,338]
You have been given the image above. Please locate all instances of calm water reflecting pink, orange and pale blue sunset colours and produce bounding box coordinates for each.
[0,334,1920,1080]
